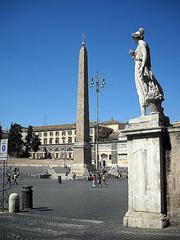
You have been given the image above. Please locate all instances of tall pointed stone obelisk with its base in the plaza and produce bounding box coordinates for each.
[72,34,91,176]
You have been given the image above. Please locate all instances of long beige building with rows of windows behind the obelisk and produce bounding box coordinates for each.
[33,119,127,167]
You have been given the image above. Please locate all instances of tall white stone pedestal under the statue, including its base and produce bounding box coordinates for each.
[123,113,168,228]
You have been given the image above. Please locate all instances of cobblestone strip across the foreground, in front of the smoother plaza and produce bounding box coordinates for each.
[0,212,180,240]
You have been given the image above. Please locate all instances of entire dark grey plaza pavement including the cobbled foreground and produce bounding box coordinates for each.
[0,174,180,240]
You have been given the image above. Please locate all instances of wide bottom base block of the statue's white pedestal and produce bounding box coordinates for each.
[123,210,169,229]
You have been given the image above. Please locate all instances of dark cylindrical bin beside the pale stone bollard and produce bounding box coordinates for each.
[22,185,33,210]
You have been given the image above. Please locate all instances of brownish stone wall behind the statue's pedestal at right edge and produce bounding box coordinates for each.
[166,126,180,225]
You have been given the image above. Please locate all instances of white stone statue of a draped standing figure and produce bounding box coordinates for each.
[129,28,164,115]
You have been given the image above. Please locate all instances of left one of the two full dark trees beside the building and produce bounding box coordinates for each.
[8,123,24,157]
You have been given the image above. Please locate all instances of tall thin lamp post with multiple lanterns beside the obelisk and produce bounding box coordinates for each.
[90,70,105,171]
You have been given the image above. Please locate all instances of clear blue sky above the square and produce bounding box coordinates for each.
[0,0,180,129]
